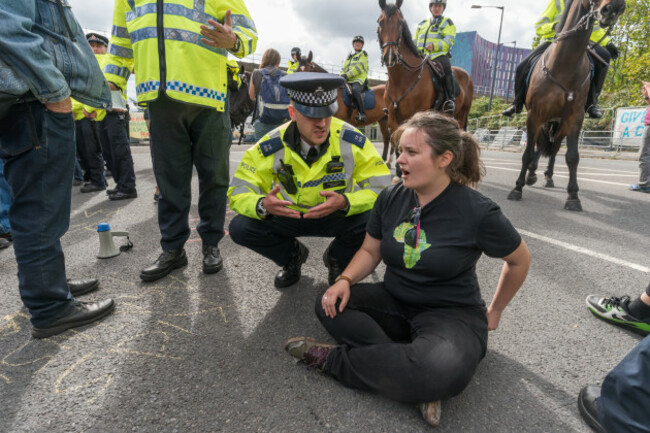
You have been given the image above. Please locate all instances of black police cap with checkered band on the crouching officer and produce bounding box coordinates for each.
[280,72,345,118]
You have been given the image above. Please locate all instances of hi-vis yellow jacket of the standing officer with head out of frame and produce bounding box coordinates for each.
[104,0,257,111]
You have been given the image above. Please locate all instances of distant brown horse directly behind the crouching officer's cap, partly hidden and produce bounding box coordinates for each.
[298,51,395,167]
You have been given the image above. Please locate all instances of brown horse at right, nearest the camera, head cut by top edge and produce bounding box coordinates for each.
[508,0,625,211]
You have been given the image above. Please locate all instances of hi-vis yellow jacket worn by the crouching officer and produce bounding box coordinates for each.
[228,118,391,219]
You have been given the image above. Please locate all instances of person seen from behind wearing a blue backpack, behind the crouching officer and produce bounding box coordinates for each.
[248,48,291,141]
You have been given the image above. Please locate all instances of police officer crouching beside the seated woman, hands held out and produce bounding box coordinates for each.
[228,72,390,288]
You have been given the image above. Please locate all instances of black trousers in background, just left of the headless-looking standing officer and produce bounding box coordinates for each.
[99,111,135,193]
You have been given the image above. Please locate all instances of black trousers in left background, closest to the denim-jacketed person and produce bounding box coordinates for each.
[75,118,106,186]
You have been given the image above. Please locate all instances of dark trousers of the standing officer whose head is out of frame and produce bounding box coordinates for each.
[148,96,232,250]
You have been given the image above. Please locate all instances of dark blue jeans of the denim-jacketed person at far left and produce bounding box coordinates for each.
[0,102,75,326]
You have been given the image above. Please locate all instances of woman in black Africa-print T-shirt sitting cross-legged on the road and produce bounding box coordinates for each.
[285,112,530,425]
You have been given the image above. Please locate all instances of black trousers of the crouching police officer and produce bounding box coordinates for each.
[229,212,370,268]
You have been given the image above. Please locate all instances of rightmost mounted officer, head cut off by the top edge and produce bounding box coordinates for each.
[501,0,618,119]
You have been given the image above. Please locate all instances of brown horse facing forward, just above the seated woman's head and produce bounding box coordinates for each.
[377,0,474,131]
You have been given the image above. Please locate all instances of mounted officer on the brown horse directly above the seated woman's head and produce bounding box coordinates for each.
[413,0,456,114]
